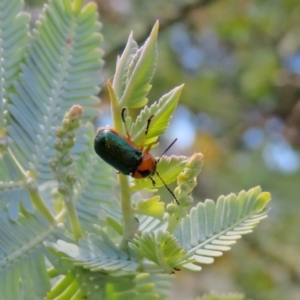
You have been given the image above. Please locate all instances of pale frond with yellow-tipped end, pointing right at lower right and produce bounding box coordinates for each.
[174,187,270,270]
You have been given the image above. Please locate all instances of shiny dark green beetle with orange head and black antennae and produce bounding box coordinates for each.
[94,108,179,205]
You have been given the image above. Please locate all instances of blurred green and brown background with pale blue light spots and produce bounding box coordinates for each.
[25,0,300,300]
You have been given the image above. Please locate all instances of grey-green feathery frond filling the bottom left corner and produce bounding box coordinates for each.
[0,210,61,300]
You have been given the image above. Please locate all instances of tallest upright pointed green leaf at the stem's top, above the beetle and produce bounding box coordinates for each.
[117,22,158,108]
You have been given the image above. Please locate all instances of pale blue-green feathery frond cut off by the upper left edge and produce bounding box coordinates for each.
[0,0,29,129]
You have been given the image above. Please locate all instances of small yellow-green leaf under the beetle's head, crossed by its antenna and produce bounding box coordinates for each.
[130,155,187,192]
